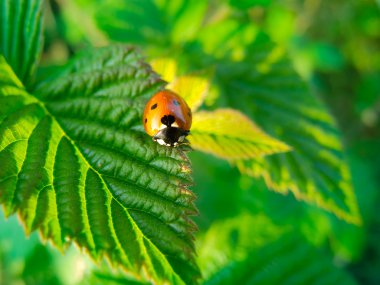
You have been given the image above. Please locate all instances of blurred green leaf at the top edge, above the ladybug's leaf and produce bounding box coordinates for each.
[92,0,207,45]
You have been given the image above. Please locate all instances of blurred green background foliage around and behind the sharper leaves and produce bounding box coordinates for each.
[0,0,380,284]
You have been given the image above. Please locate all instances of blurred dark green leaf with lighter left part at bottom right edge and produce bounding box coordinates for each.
[199,212,356,285]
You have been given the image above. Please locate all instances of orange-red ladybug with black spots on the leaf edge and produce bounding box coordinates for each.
[143,90,192,147]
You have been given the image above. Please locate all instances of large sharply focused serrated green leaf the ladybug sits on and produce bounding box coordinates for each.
[0,46,199,284]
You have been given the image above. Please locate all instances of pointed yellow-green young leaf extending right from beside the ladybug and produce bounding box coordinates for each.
[189,109,290,160]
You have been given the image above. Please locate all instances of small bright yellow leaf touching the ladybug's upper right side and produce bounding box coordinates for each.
[167,75,210,112]
